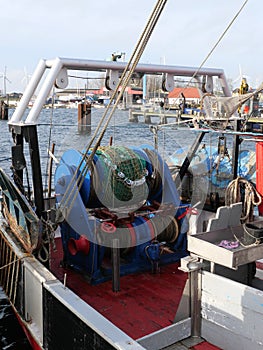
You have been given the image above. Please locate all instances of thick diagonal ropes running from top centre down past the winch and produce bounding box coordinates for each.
[56,0,167,219]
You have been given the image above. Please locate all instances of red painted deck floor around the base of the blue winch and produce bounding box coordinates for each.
[51,240,221,350]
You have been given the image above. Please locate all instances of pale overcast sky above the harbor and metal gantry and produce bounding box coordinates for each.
[0,0,263,92]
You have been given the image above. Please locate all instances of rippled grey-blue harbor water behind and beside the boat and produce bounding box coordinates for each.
[0,108,256,350]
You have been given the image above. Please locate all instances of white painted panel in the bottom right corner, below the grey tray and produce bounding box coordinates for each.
[201,271,263,350]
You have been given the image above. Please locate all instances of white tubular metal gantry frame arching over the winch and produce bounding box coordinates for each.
[9,57,231,125]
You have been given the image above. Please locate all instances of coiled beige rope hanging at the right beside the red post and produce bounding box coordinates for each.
[225,177,262,222]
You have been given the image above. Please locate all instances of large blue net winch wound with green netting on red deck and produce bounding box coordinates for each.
[55,145,188,283]
